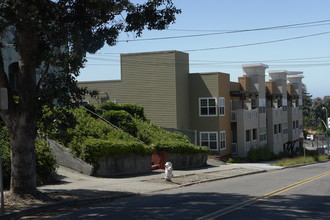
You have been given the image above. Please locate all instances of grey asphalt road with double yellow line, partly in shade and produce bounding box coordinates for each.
[21,162,330,220]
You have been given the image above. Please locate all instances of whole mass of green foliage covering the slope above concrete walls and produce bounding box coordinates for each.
[36,103,208,167]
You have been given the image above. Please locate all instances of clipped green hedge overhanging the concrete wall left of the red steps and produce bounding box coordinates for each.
[82,139,153,167]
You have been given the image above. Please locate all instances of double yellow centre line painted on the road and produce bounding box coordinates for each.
[197,172,330,220]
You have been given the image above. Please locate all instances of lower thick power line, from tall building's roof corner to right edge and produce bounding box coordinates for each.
[183,31,330,52]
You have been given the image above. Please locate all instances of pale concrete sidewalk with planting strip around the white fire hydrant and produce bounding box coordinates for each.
[0,159,283,219]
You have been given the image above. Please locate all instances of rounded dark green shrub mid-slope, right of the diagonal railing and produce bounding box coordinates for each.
[102,110,137,136]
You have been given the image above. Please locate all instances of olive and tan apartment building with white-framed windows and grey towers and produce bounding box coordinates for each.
[79,51,303,157]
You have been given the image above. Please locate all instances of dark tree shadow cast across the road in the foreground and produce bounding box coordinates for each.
[29,193,330,219]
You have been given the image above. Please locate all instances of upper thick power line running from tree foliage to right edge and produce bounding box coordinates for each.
[117,20,330,42]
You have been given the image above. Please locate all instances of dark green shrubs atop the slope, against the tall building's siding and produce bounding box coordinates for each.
[98,102,146,120]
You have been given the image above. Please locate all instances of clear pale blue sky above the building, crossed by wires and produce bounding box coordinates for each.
[78,0,330,98]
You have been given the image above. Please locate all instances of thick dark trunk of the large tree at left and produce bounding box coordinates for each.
[6,13,39,195]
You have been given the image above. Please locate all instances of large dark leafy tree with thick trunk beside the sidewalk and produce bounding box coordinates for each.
[0,0,181,195]
